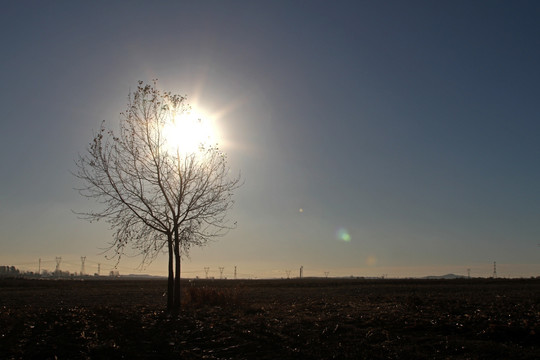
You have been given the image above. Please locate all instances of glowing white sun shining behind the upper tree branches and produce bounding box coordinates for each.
[163,108,218,153]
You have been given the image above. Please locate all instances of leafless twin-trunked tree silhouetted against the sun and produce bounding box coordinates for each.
[74,81,240,311]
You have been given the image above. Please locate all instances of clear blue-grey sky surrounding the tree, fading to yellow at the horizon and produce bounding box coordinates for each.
[0,1,540,278]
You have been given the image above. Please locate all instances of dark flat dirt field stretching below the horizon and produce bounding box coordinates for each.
[0,279,540,359]
